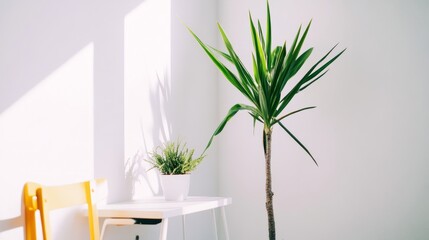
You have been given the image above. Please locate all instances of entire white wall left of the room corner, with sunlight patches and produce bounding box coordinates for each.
[0,0,217,240]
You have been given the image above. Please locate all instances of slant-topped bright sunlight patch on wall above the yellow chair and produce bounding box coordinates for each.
[0,43,94,234]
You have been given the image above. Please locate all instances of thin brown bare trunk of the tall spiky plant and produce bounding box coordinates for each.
[264,129,276,240]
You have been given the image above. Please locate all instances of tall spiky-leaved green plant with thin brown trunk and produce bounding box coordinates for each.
[189,1,345,240]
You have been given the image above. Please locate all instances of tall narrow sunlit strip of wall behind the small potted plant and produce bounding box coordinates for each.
[124,0,171,198]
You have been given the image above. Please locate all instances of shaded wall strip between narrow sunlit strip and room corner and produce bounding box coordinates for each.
[171,0,218,199]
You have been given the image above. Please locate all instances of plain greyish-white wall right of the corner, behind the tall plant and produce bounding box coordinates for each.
[215,0,429,240]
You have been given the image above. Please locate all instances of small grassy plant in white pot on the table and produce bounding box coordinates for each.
[147,141,204,201]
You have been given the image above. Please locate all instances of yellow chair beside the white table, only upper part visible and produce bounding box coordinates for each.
[24,179,106,240]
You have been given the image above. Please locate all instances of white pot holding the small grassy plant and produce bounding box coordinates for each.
[161,174,191,201]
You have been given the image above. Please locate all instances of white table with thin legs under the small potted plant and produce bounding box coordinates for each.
[97,197,232,240]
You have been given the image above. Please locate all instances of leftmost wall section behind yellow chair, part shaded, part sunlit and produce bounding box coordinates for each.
[0,1,141,239]
